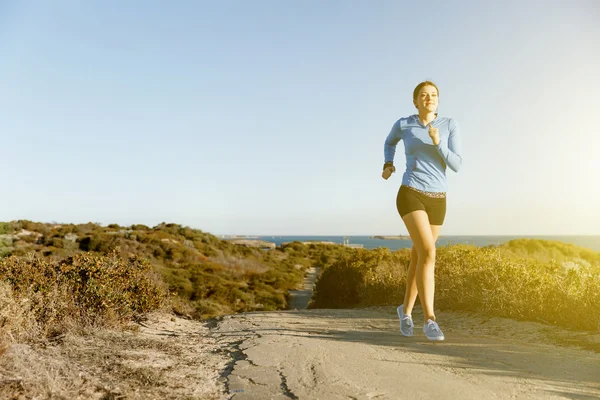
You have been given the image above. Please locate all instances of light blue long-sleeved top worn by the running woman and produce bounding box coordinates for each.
[383,115,462,192]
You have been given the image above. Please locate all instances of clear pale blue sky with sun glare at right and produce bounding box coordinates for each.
[0,0,600,235]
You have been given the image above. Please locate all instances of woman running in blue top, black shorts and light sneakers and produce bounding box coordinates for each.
[382,81,462,340]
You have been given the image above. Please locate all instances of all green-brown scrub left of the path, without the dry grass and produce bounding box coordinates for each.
[0,220,352,340]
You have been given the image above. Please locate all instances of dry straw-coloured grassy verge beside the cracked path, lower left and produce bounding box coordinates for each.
[0,314,228,400]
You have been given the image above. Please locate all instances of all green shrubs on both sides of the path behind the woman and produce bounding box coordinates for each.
[0,220,600,342]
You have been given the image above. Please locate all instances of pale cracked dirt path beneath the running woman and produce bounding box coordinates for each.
[211,307,600,400]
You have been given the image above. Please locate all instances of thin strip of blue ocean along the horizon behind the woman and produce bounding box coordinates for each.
[257,236,600,251]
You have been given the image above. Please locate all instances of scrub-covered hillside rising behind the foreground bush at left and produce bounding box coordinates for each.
[0,221,354,318]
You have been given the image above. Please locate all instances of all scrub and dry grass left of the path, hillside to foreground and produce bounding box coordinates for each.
[0,221,358,399]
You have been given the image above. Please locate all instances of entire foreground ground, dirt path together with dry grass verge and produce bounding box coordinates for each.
[0,307,600,400]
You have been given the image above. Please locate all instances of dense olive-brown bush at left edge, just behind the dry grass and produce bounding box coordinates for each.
[0,252,165,336]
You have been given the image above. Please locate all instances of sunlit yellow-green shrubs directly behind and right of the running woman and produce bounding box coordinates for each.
[310,239,600,331]
